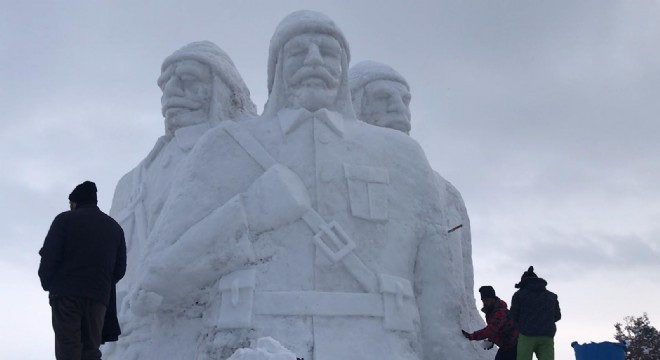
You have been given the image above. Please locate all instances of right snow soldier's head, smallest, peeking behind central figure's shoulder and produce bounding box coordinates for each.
[348,61,411,134]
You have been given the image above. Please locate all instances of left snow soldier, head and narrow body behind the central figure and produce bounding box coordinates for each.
[110,41,256,333]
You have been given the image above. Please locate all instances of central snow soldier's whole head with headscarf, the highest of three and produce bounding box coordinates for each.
[264,10,355,118]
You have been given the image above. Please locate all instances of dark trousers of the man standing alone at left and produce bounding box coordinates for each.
[50,295,105,360]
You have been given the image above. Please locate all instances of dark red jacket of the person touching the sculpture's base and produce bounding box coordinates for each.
[470,298,518,350]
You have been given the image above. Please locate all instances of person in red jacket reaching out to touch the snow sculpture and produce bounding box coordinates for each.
[461,285,518,360]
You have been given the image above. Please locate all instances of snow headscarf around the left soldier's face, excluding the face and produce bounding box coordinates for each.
[158,41,257,128]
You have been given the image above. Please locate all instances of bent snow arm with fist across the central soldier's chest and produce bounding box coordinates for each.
[132,165,311,314]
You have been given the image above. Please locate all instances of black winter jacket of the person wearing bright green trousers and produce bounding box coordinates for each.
[511,278,561,336]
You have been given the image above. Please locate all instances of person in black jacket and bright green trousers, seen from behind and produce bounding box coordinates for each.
[511,266,561,360]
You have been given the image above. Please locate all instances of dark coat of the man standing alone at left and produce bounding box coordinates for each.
[39,205,126,306]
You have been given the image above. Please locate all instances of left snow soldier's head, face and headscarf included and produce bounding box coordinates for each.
[158,41,256,133]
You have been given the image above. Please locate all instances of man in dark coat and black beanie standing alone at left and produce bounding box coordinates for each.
[39,181,126,360]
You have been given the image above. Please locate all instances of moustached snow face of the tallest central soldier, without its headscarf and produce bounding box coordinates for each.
[281,33,342,111]
